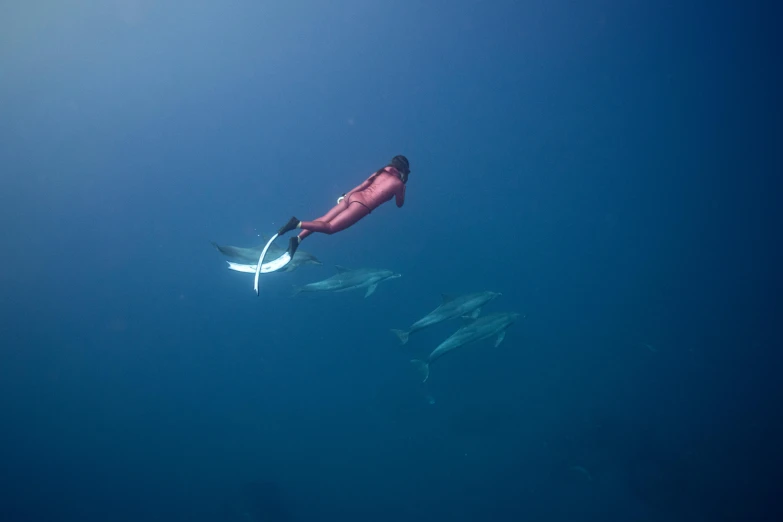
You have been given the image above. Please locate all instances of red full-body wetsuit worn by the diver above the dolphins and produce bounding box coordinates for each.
[299,167,405,240]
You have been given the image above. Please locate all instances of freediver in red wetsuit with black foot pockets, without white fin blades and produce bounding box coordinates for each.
[277,155,411,258]
